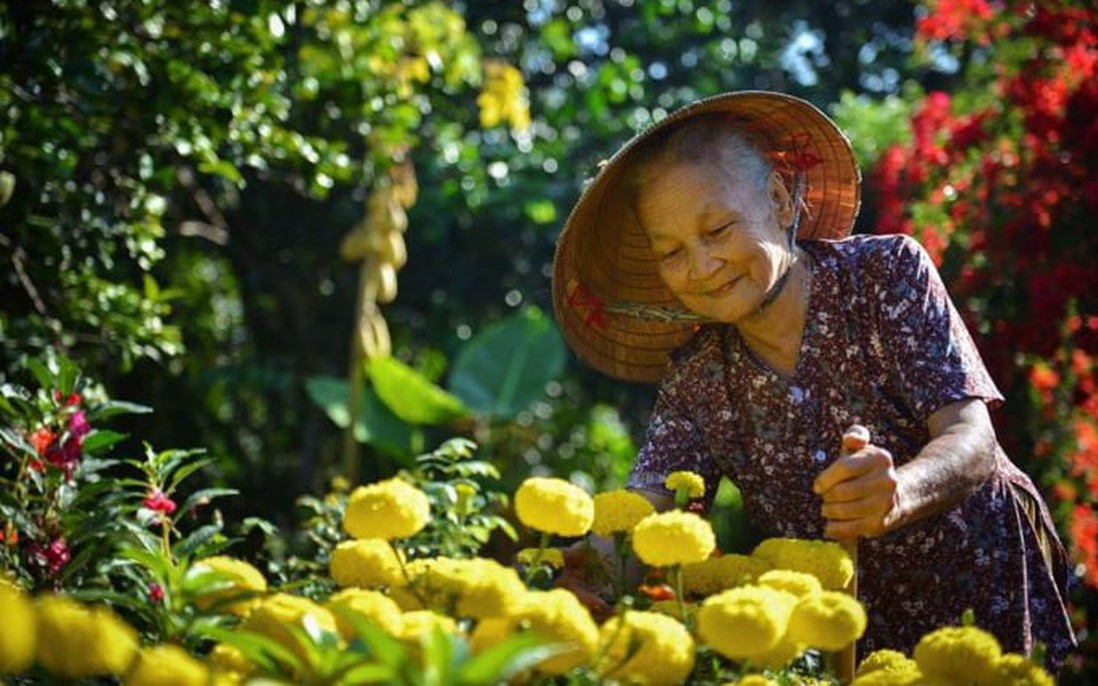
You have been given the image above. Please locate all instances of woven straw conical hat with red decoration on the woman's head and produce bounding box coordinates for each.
[552,91,861,383]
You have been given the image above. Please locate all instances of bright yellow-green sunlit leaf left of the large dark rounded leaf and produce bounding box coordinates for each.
[366,357,469,425]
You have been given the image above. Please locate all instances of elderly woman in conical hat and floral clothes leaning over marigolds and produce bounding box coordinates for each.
[553,91,1074,668]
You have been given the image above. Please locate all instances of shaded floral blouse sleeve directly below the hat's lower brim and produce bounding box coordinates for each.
[626,370,720,506]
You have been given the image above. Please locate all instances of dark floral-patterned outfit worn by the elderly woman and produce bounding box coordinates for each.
[629,236,1075,668]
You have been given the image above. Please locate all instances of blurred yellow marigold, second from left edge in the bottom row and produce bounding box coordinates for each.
[35,596,137,678]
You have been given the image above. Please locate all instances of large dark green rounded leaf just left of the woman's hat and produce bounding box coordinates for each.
[450,307,565,418]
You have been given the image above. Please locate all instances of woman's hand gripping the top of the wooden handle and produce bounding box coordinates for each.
[813,427,900,539]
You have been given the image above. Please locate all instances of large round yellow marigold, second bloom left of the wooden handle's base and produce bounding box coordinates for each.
[697,586,797,660]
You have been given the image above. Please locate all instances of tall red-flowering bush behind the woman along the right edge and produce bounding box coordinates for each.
[869,0,1098,676]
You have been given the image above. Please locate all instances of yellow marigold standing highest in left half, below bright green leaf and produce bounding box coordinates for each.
[344,479,430,541]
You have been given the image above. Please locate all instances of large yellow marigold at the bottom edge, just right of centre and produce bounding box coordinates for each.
[597,611,694,686]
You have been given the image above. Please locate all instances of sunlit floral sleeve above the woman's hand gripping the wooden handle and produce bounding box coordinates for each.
[878,236,1002,419]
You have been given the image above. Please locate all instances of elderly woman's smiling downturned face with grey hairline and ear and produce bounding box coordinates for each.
[635,162,792,324]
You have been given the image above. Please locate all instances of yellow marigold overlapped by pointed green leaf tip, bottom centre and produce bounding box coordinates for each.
[512,588,598,674]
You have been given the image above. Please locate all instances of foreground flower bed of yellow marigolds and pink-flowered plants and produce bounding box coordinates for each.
[0,360,1052,685]
